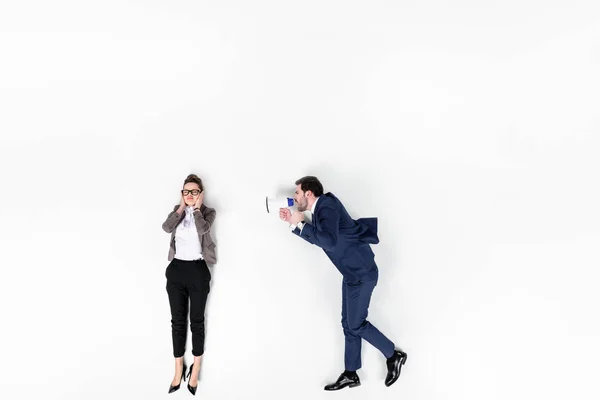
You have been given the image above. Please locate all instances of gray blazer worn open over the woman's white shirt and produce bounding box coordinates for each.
[163,204,217,264]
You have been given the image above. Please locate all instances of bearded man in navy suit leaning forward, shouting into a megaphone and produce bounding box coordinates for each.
[279,176,407,390]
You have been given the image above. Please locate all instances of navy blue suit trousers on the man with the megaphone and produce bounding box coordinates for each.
[342,279,395,371]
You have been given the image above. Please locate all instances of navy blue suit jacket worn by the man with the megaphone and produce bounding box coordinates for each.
[292,193,379,282]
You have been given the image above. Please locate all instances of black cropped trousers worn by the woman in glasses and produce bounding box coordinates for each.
[165,259,210,357]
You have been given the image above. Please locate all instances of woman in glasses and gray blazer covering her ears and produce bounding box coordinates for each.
[162,174,217,395]
